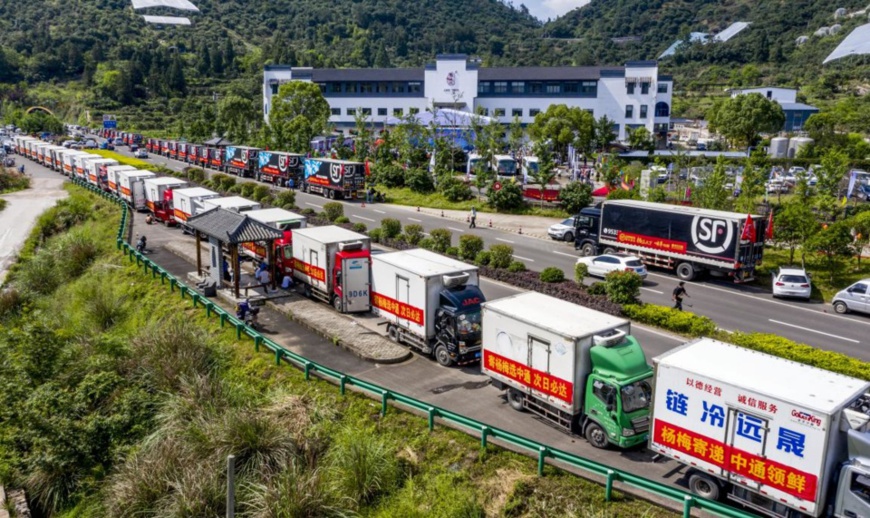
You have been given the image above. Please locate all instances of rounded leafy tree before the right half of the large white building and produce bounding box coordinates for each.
[529,104,595,158]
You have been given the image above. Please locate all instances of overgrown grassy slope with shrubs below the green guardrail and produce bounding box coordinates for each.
[0,187,676,518]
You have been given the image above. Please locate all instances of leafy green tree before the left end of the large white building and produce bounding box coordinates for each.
[269,81,330,153]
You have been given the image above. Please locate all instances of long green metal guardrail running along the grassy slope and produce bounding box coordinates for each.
[73,179,755,518]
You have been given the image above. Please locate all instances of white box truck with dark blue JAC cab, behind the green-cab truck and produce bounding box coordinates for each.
[372,248,486,366]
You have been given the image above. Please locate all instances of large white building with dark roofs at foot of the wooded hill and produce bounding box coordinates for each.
[263,54,673,140]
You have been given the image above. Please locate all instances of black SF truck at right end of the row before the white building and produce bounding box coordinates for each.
[302,158,366,200]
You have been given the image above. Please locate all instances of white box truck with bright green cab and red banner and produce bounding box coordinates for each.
[481,292,653,448]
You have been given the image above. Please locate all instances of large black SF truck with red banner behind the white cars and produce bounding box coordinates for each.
[574,200,767,282]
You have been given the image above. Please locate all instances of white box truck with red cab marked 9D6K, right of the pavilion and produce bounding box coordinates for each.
[293,225,371,313]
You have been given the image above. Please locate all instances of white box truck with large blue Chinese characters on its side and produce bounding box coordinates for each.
[649,338,870,517]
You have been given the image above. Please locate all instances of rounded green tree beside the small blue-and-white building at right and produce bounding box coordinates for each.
[707,93,785,146]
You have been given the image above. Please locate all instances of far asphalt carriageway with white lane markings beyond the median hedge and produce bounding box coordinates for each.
[117,143,870,361]
